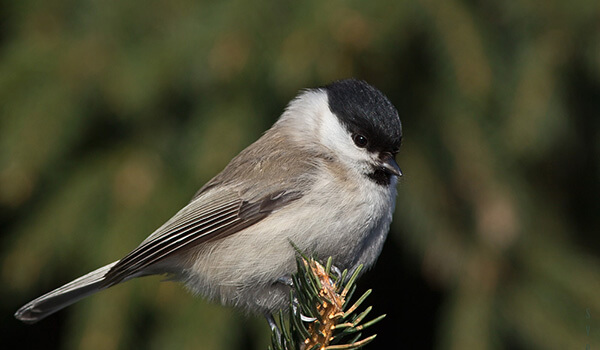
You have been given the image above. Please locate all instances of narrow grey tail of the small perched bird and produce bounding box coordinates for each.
[15,261,117,323]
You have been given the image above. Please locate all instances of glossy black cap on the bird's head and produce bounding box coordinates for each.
[324,79,402,152]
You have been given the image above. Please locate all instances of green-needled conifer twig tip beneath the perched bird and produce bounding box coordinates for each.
[269,254,385,350]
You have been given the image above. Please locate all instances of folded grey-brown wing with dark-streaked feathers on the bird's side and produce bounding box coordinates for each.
[104,190,302,286]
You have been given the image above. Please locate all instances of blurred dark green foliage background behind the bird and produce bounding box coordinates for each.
[0,0,600,350]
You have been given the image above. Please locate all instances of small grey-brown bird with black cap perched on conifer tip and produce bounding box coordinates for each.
[15,79,402,323]
